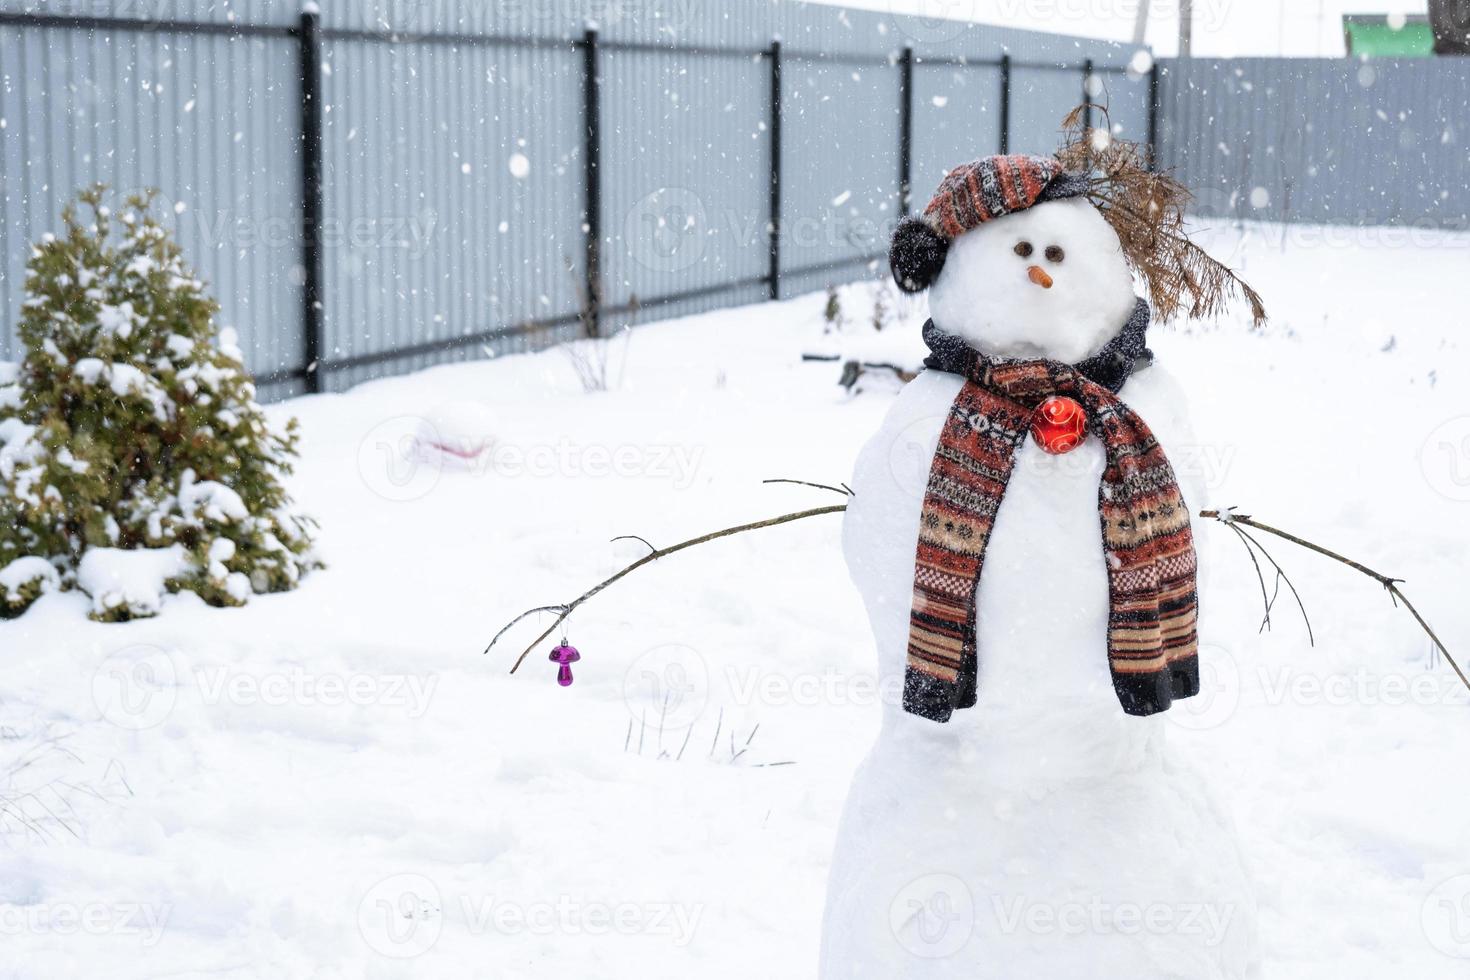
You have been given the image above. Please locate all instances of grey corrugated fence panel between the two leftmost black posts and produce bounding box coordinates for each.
[323,38,584,389]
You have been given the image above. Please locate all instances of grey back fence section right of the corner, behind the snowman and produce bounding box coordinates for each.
[1160,59,1470,228]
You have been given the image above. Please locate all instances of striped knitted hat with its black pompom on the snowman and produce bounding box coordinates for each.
[888,153,1089,292]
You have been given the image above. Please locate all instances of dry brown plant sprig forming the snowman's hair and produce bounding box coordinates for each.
[1057,104,1266,326]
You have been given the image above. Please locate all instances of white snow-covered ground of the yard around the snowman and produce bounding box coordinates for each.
[0,221,1470,980]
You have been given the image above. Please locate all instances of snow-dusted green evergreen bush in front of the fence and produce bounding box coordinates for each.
[0,187,315,620]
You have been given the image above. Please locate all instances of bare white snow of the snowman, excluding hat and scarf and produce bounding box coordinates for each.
[820,189,1255,980]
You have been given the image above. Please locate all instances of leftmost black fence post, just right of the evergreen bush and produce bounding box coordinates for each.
[297,12,323,395]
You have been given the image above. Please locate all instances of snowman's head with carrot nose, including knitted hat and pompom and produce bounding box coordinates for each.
[889,157,1136,363]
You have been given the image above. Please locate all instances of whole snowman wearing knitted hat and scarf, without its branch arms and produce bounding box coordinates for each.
[820,149,1258,980]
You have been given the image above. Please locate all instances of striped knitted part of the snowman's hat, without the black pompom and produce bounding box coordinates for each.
[923,153,1088,241]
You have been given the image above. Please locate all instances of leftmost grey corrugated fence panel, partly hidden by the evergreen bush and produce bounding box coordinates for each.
[0,25,301,373]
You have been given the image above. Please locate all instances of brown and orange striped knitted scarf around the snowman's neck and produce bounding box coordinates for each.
[904,314,1200,721]
